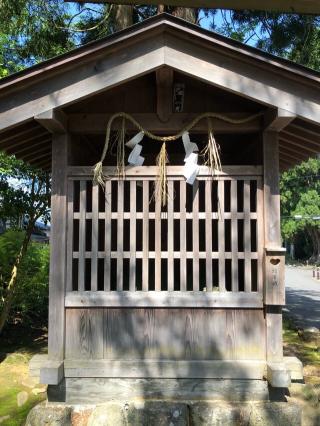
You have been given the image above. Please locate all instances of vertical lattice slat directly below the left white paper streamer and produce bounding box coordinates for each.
[129,180,137,291]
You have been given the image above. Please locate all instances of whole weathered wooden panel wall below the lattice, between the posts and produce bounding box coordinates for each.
[66,308,265,360]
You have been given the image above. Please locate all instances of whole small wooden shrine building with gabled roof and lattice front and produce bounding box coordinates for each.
[0,14,320,403]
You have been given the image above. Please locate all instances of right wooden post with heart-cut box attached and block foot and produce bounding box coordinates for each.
[263,130,290,387]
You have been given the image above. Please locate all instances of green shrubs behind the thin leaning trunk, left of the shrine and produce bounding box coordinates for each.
[0,229,49,323]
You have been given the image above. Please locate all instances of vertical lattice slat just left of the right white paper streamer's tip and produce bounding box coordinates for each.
[180,180,187,291]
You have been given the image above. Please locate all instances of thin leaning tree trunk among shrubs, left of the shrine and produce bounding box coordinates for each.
[0,220,35,335]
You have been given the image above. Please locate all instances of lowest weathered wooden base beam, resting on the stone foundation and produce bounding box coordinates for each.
[48,377,269,404]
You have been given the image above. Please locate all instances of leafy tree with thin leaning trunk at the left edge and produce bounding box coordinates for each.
[0,153,50,334]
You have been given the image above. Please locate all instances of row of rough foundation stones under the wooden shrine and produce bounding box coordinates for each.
[26,401,301,426]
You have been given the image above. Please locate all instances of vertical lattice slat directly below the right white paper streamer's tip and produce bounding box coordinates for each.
[192,180,199,291]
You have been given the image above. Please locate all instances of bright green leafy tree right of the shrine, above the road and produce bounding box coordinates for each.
[280,158,320,262]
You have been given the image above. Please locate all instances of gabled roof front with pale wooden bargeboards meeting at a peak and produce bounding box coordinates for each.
[0,14,320,170]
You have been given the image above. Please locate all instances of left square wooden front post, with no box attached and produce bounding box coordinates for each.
[48,133,69,361]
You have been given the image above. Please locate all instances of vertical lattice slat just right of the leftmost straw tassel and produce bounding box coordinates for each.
[104,180,111,291]
